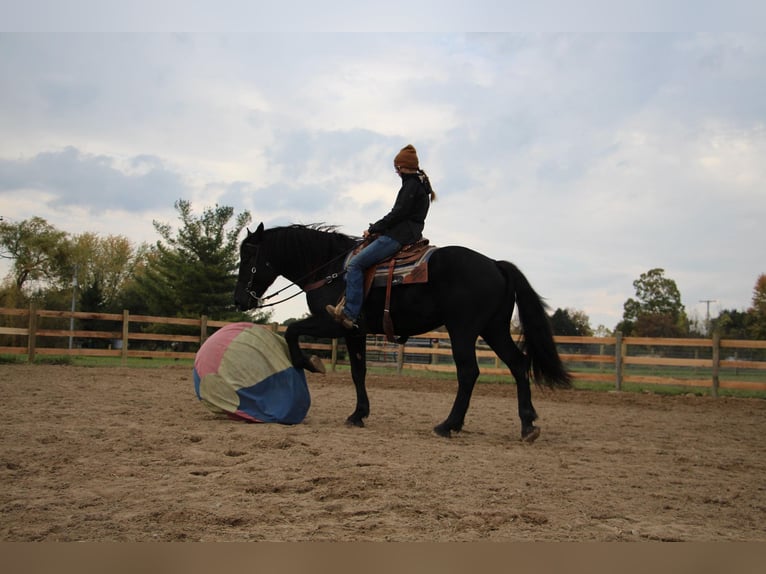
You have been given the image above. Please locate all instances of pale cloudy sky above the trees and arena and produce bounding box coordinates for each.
[0,1,766,329]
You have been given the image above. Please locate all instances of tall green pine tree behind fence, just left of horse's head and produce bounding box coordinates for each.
[127,200,251,319]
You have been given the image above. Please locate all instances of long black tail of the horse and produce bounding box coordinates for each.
[497,261,572,388]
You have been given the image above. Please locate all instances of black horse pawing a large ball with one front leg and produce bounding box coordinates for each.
[234,223,571,442]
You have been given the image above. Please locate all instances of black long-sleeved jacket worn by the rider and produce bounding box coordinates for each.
[368,173,431,245]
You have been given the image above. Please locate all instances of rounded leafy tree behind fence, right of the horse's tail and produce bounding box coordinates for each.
[617,268,688,337]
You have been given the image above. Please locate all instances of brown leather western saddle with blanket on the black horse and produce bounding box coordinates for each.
[343,239,438,342]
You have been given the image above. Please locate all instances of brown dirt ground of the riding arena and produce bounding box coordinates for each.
[0,365,766,541]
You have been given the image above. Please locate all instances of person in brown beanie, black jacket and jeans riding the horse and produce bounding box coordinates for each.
[326,145,436,329]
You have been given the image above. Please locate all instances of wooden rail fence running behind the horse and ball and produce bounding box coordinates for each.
[0,306,766,396]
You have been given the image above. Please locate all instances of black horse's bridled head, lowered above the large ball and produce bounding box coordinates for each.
[234,223,279,311]
